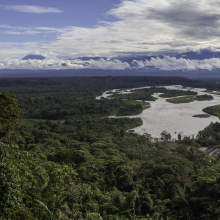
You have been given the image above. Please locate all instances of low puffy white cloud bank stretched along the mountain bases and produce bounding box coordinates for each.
[0,56,220,71]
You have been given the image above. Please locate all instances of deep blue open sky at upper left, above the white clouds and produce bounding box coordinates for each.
[0,0,120,28]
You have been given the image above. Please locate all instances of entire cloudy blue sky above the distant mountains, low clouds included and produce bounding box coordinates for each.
[0,0,220,69]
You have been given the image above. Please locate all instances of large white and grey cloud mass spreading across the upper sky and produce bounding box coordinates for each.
[3,0,220,62]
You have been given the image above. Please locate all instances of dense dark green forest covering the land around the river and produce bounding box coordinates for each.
[0,76,220,220]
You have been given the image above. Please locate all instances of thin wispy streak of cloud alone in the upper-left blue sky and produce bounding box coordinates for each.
[1,5,62,14]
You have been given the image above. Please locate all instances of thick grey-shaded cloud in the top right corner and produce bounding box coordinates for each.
[143,0,220,39]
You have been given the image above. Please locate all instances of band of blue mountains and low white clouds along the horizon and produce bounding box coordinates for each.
[0,49,220,75]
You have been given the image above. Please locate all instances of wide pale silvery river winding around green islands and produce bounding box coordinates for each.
[97,85,220,139]
